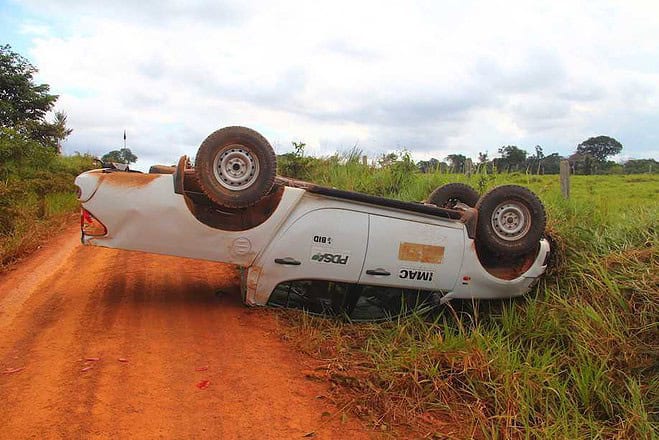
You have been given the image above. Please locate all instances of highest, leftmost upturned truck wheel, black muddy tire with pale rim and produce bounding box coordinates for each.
[195,127,277,208]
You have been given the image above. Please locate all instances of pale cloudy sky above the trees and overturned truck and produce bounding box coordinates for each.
[0,0,659,170]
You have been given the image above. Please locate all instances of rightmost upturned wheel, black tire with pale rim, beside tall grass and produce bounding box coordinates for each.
[476,185,547,256]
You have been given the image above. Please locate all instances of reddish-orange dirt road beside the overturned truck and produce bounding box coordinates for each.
[0,230,369,439]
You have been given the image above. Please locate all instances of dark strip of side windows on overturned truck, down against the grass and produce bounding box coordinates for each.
[268,280,439,321]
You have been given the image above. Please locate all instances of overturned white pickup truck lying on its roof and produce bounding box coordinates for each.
[76,127,549,320]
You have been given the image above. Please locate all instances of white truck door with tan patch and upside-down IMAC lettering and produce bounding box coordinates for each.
[359,215,464,290]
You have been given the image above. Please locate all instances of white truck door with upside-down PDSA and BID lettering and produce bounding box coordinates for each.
[250,208,368,304]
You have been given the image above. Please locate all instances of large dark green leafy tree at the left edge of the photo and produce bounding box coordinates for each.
[0,45,57,147]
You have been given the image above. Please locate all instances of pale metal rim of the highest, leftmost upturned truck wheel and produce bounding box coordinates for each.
[213,144,259,191]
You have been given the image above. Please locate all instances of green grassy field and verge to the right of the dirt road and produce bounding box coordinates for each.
[282,167,659,439]
